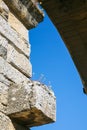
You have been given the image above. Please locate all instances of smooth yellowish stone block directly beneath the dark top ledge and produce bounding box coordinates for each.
[8,12,28,40]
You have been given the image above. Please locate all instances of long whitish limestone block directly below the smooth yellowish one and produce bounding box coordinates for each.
[0,16,30,57]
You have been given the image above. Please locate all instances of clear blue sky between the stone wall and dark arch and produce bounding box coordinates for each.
[29,12,87,130]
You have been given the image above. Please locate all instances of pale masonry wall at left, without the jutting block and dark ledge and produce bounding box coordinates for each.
[0,0,32,130]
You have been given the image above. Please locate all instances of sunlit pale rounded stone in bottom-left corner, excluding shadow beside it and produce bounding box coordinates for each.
[0,112,15,130]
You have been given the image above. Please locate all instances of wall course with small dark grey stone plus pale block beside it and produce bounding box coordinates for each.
[0,35,32,77]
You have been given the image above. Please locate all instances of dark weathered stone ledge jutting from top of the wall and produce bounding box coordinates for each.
[4,0,43,29]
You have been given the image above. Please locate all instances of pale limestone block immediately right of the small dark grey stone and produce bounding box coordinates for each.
[7,45,32,77]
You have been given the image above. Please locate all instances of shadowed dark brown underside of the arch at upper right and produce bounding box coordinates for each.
[39,0,87,90]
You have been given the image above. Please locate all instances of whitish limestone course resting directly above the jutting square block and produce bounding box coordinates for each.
[0,57,29,84]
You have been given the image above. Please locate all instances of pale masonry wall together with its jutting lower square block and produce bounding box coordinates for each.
[0,0,56,130]
